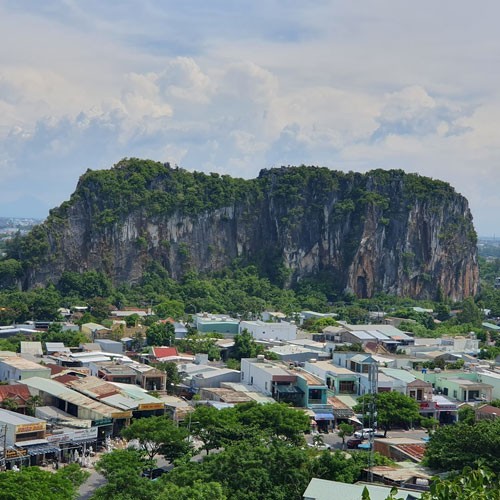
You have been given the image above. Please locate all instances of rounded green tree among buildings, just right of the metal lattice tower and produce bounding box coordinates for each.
[353,392,420,437]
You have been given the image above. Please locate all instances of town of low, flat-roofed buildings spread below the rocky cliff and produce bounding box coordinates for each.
[0,294,500,500]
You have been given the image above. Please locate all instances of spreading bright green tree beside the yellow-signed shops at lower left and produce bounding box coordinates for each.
[122,417,191,461]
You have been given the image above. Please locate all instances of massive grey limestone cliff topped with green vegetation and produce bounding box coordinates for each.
[11,160,478,300]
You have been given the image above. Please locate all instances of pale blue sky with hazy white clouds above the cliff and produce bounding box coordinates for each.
[0,0,500,236]
